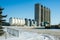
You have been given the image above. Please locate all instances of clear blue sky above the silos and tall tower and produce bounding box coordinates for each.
[0,0,60,24]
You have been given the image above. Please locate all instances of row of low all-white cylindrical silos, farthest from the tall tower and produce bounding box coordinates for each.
[9,17,25,26]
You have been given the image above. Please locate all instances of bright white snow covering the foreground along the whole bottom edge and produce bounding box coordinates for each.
[0,26,60,40]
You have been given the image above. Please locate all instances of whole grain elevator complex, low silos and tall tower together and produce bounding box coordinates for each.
[1,3,50,28]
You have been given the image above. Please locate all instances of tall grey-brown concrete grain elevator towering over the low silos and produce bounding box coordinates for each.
[34,3,50,27]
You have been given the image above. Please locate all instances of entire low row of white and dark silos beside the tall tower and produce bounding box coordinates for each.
[9,17,37,27]
